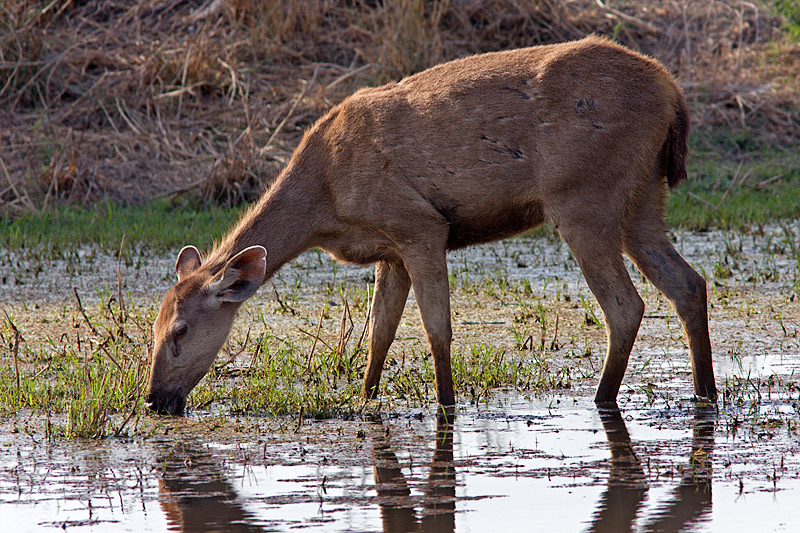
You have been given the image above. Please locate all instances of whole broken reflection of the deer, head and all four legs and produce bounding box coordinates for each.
[153,407,715,533]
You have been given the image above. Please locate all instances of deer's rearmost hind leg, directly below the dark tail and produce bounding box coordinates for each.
[625,225,717,398]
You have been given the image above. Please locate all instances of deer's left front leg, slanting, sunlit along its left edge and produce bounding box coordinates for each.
[361,261,411,398]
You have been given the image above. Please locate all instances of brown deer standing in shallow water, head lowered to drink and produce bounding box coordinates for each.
[147,36,716,413]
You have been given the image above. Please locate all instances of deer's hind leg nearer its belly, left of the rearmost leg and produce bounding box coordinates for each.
[559,221,644,403]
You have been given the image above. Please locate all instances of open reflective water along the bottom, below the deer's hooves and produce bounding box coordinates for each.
[0,397,800,532]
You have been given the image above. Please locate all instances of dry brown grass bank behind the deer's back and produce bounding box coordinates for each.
[0,0,800,214]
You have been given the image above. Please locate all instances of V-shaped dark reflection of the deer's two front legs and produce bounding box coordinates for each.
[372,411,456,533]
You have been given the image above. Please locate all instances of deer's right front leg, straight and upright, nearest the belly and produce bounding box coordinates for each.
[404,245,455,405]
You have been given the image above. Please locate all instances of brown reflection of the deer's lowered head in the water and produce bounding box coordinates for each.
[158,447,263,533]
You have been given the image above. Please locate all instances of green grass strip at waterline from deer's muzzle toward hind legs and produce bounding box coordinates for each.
[190,336,572,418]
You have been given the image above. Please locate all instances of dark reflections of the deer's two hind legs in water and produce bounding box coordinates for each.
[590,407,714,533]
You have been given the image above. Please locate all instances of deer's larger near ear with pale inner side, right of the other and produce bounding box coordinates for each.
[208,246,267,302]
